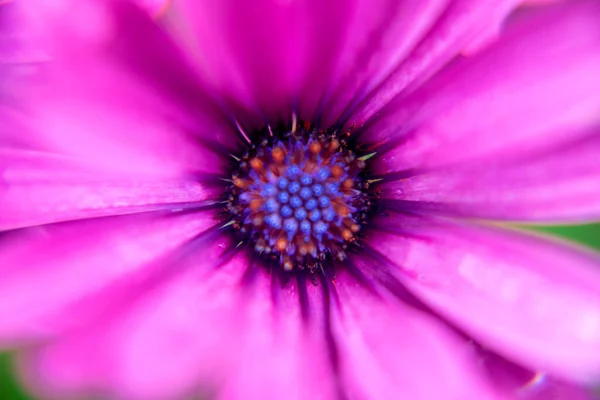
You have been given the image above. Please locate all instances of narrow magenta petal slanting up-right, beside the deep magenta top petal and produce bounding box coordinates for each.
[313,0,449,126]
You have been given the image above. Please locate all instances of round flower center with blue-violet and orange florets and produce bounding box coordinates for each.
[227,130,370,271]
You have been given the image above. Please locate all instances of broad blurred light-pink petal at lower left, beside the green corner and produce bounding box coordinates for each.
[18,240,247,400]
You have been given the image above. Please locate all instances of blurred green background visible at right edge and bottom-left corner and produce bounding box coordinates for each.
[0,224,600,400]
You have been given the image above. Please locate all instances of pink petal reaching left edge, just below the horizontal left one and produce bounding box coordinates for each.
[0,213,214,343]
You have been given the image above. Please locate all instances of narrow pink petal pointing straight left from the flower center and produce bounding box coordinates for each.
[0,148,216,229]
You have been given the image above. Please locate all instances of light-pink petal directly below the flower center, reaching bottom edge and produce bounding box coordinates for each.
[218,271,338,400]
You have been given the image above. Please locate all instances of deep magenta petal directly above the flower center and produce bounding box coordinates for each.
[174,0,353,122]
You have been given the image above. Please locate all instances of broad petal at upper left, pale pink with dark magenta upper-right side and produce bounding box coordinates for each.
[23,0,236,176]
